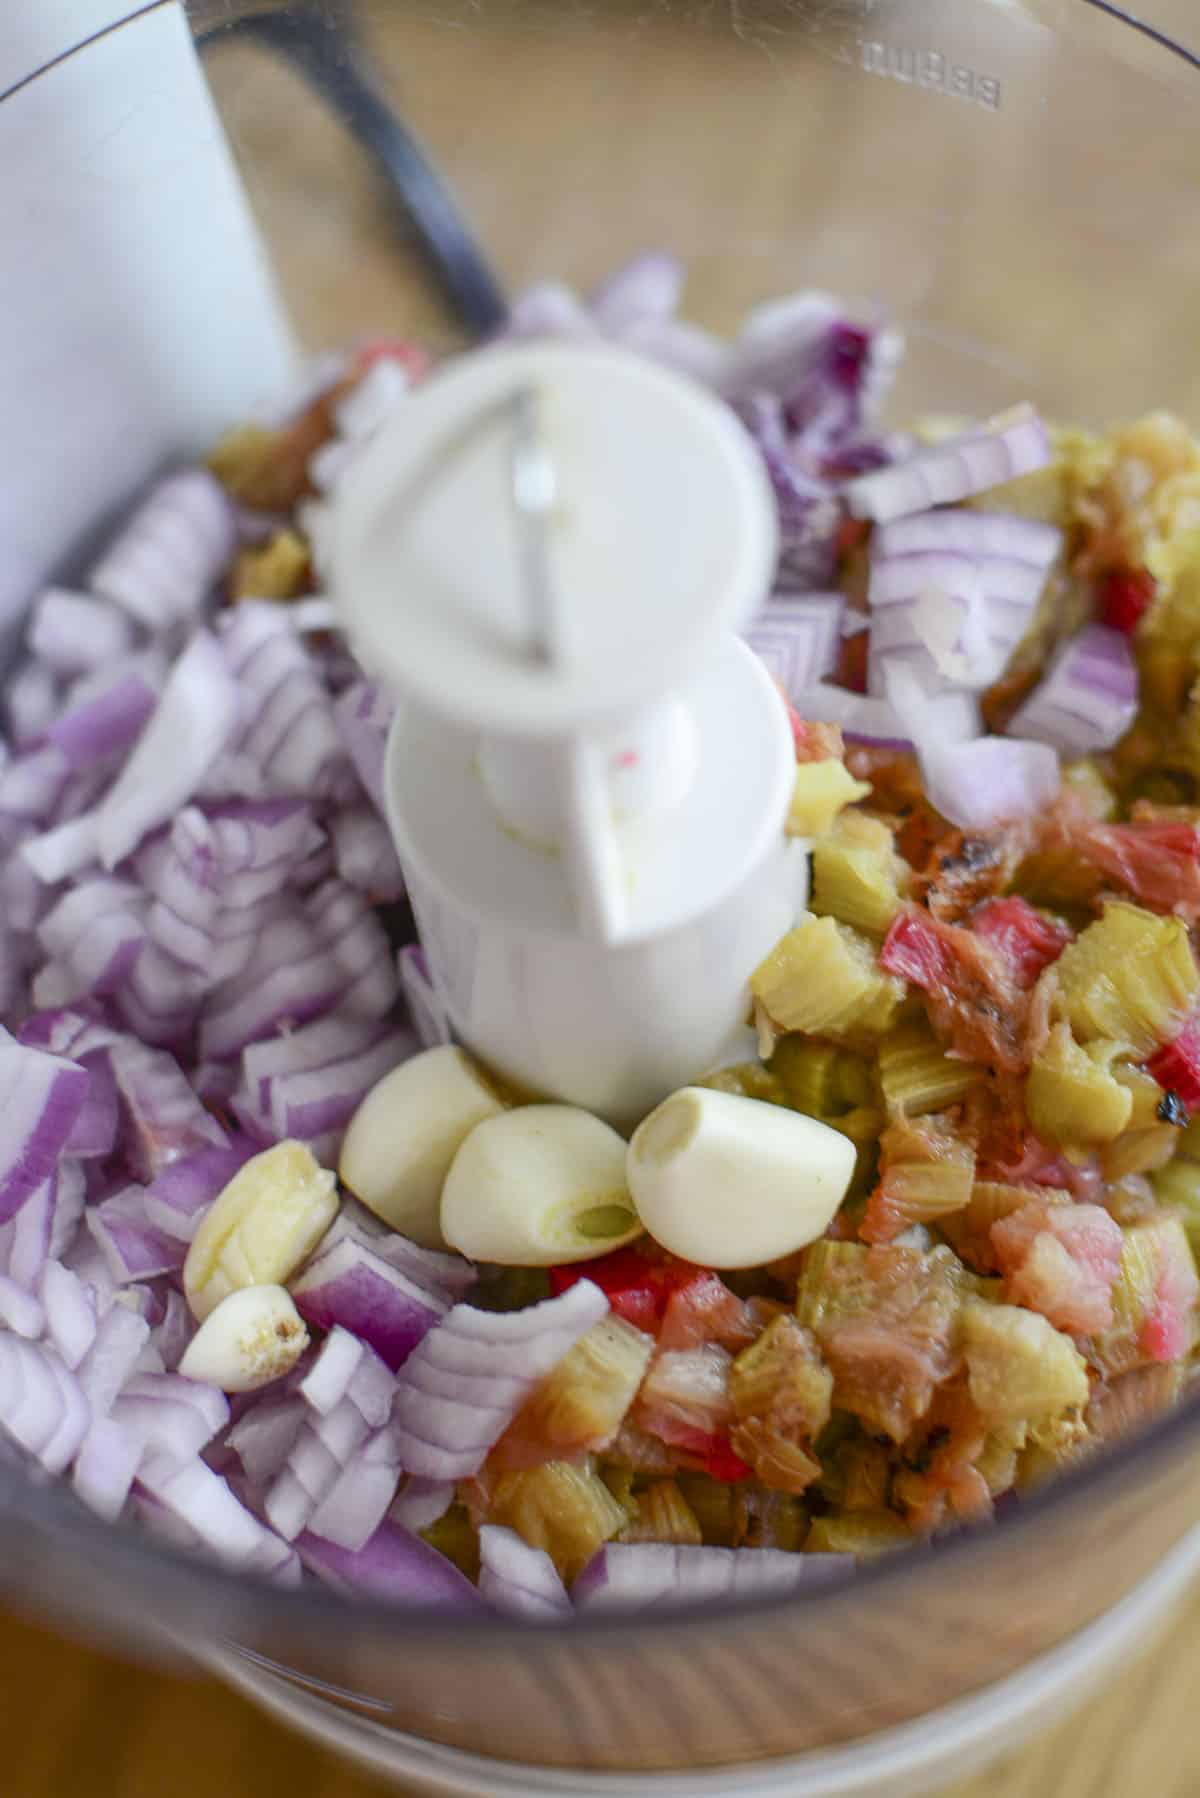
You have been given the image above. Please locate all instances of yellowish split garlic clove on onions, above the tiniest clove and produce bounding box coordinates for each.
[184,1142,338,1322]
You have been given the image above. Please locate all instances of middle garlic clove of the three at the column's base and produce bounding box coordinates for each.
[441,1106,642,1268]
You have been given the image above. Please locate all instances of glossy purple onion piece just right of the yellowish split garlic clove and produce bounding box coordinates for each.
[291,1237,446,1370]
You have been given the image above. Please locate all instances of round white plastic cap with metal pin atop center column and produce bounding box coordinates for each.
[331,345,775,739]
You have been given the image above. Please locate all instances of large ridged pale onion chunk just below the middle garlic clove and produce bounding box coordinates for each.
[392,1280,608,1480]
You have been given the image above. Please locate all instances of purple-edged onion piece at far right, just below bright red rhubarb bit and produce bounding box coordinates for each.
[1009,624,1137,755]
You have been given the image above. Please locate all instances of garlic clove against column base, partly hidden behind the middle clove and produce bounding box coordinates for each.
[338,1046,504,1248]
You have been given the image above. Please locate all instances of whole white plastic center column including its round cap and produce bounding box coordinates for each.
[331,345,804,1124]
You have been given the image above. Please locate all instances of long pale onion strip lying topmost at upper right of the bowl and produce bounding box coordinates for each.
[846,405,1054,523]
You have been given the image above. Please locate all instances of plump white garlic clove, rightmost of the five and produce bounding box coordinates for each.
[626,1086,855,1268]
